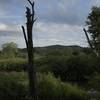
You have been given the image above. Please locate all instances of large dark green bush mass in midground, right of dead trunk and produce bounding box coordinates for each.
[35,54,100,84]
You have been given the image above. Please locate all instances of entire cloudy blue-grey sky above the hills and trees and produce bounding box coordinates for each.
[0,0,100,48]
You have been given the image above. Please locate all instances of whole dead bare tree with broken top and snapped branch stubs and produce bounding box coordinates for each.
[22,0,38,100]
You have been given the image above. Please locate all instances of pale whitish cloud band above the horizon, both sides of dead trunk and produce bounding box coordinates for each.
[0,22,86,47]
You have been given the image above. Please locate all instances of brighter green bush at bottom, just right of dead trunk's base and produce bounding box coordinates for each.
[39,74,89,100]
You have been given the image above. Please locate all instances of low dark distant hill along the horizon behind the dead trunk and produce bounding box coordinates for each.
[20,45,92,55]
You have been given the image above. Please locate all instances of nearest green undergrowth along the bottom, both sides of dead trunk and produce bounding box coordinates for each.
[0,72,89,100]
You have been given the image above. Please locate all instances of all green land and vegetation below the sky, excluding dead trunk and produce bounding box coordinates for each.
[0,42,100,100]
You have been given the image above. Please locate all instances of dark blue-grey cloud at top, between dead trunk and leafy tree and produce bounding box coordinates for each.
[36,0,89,25]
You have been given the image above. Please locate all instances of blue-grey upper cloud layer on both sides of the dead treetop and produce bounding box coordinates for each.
[0,0,92,25]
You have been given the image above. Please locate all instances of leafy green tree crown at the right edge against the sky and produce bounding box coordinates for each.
[86,7,100,53]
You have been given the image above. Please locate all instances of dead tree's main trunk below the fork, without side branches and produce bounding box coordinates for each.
[27,20,37,100]
